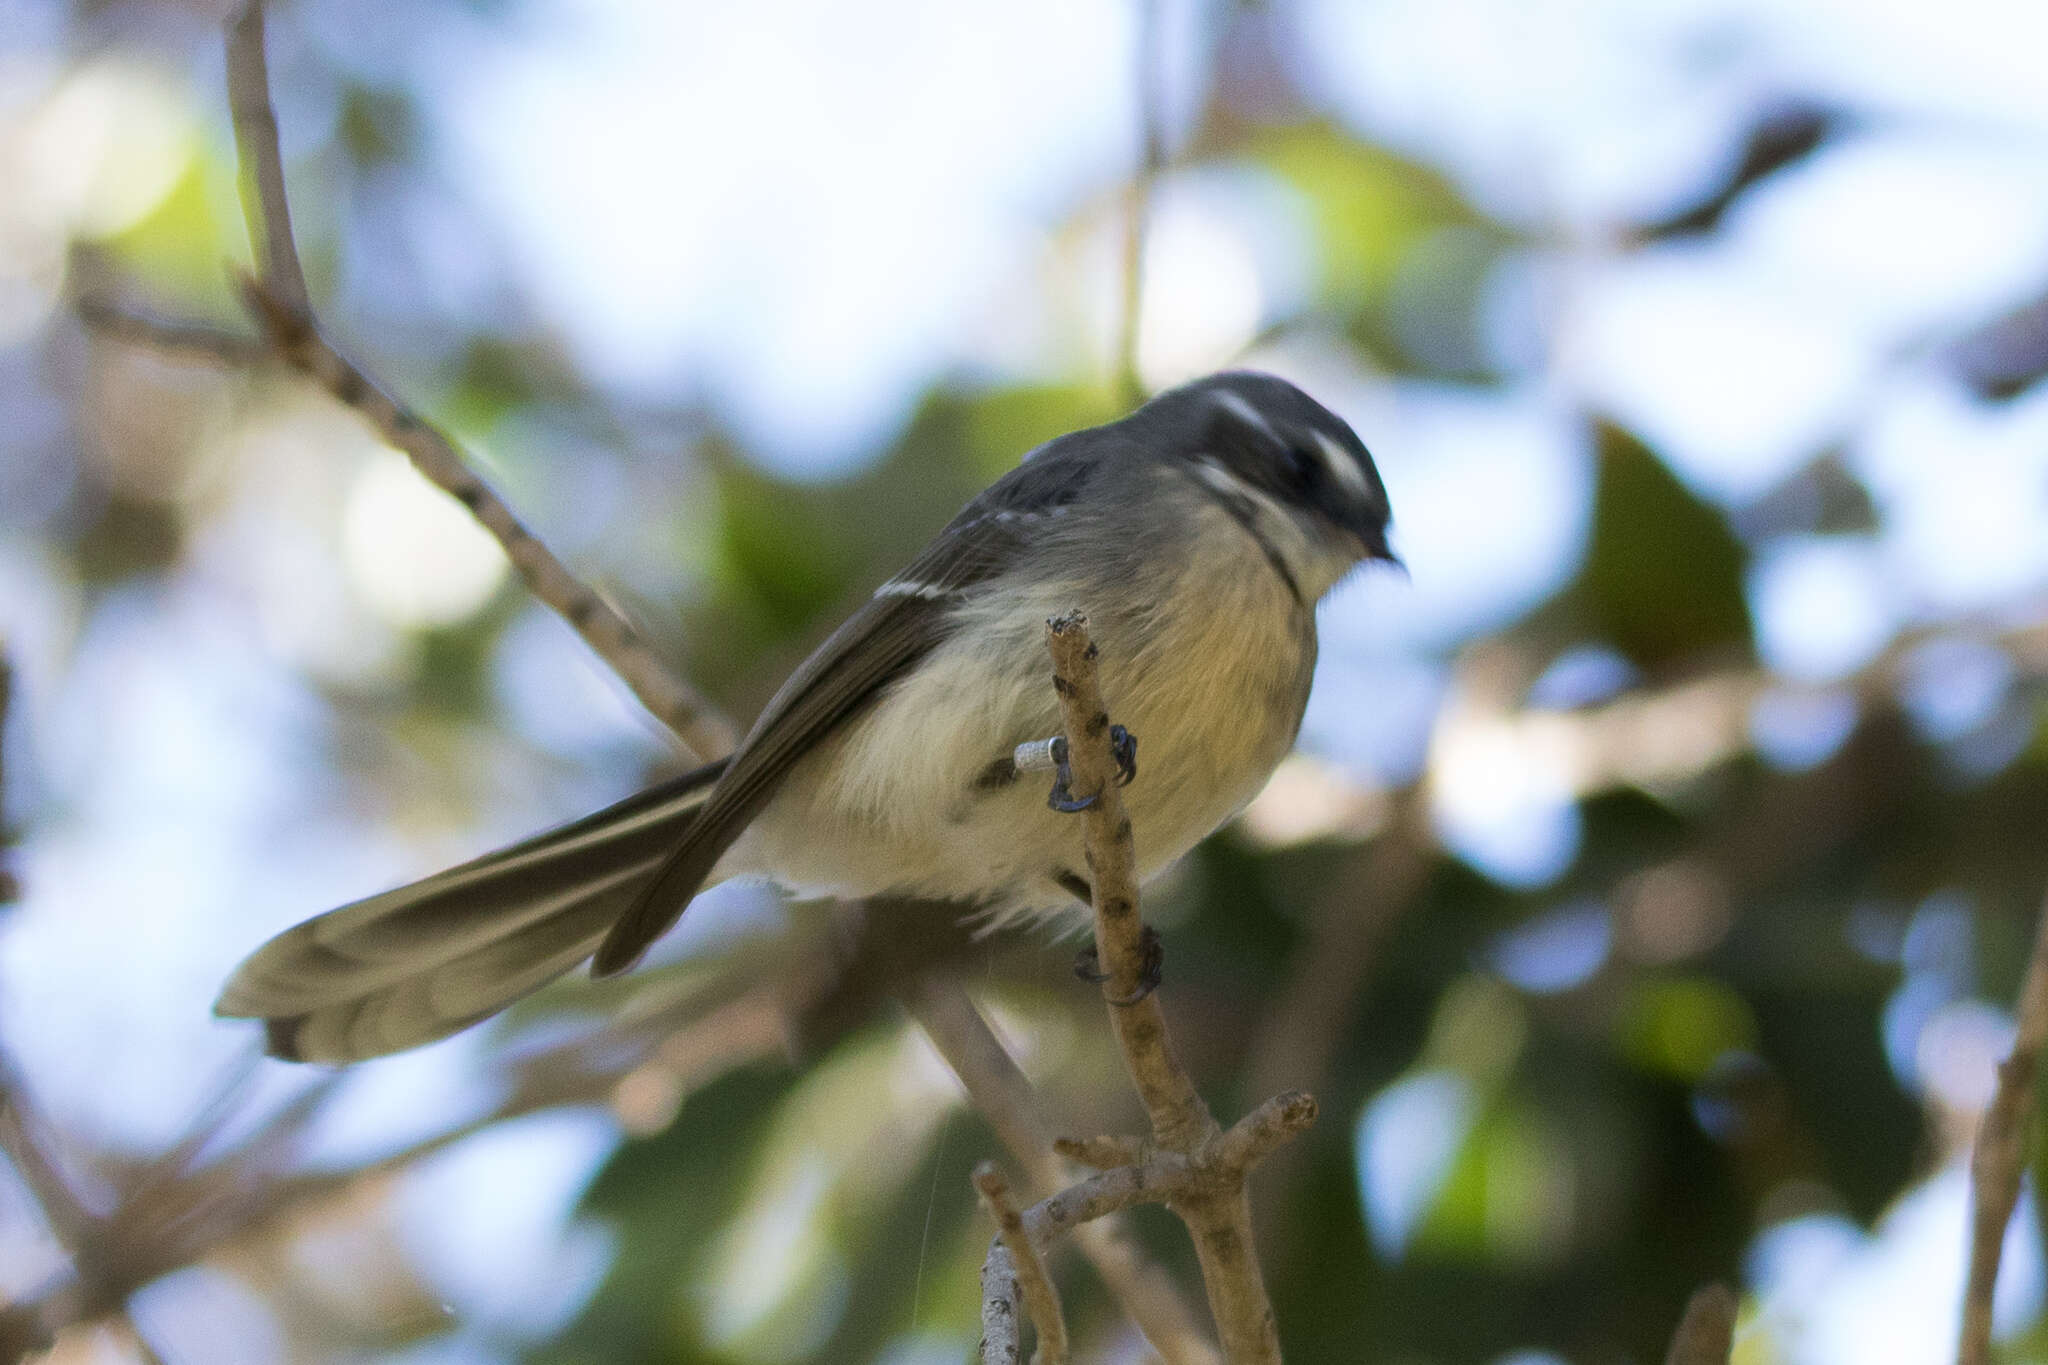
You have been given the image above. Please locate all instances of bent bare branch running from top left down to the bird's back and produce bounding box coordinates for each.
[209,0,735,757]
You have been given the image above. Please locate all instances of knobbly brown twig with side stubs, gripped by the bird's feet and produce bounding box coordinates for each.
[983,614,1315,1365]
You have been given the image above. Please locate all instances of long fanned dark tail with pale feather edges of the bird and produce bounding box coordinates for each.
[213,761,725,1062]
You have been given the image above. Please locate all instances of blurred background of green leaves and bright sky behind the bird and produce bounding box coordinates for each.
[0,0,2048,1365]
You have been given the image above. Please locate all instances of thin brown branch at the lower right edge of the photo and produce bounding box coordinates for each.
[1956,888,2048,1365]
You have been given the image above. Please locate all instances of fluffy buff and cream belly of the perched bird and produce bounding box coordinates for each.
[715,497,1315,921]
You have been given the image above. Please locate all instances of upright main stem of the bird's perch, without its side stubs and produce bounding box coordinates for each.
[1047,612,1315,1365]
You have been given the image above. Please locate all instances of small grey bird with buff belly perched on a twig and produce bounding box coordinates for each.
[215,372,1393,1062]
